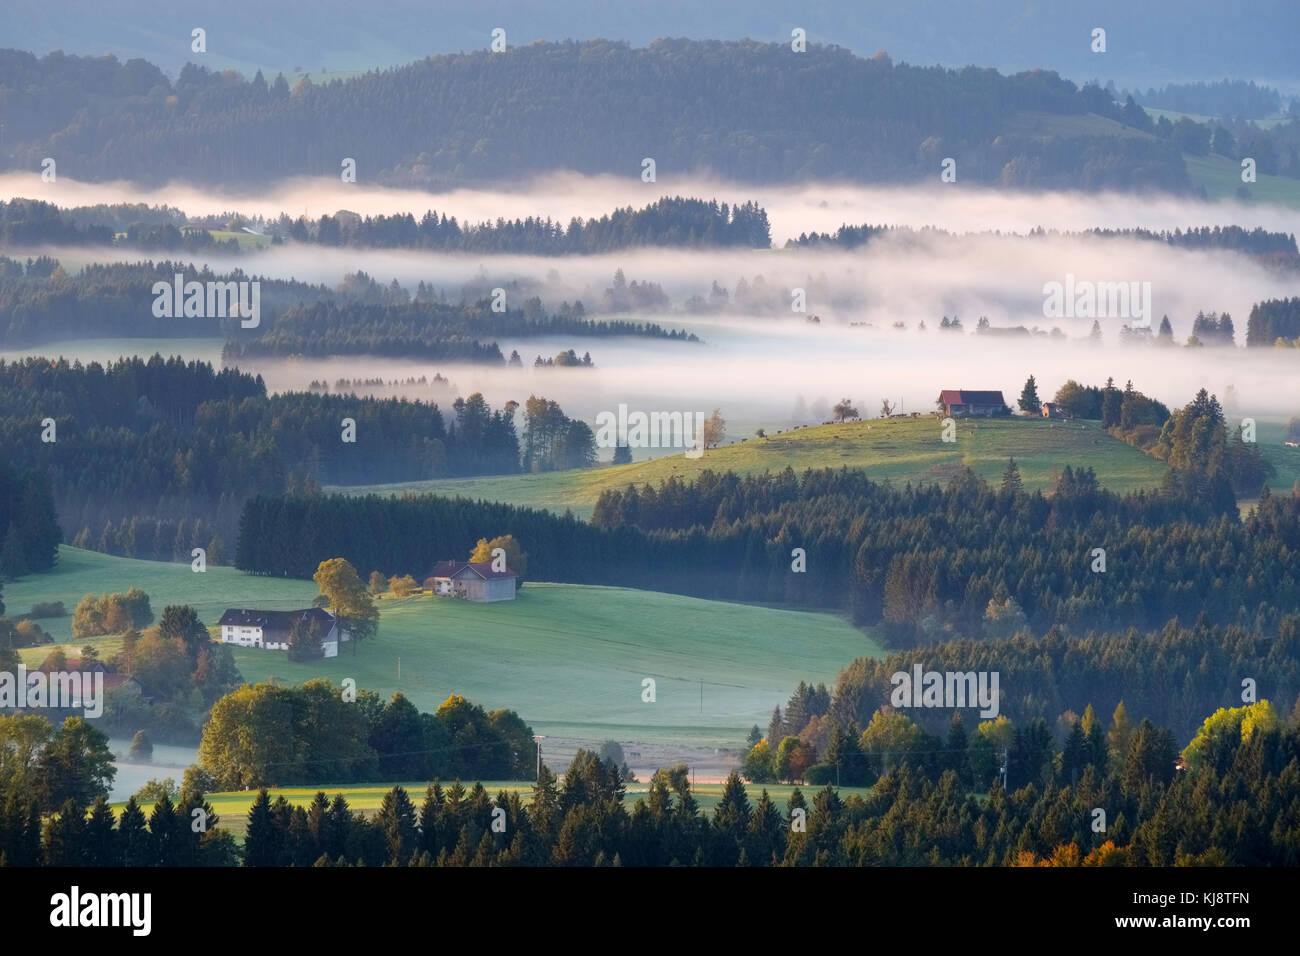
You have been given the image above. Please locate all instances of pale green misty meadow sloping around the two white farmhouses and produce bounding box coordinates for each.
[4,546,883,748]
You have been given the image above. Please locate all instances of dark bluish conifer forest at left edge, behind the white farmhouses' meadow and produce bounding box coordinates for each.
[0,355,594,561]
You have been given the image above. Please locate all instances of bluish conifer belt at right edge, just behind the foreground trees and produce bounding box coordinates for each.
[766,613,1300,759]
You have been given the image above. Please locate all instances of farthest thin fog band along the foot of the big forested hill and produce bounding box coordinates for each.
[0,165,1300,245]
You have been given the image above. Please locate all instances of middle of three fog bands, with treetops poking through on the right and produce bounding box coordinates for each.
[25,225,1300,347]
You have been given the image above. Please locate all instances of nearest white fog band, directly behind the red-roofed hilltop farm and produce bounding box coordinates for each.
[241,320,1300,437]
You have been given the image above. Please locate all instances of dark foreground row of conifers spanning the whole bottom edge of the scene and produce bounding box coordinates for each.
[12,709,1300,866]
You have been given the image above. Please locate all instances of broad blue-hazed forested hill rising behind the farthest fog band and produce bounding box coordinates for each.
[0,39,1188,191]
